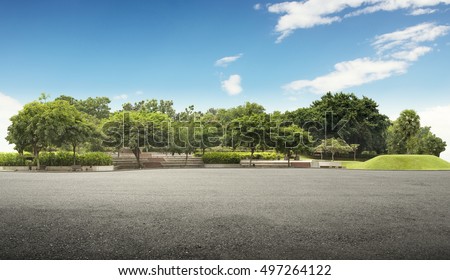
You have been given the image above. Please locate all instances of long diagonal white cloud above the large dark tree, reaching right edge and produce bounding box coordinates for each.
[283,23,450,93]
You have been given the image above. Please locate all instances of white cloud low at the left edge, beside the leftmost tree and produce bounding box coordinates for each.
[0,92,22,152]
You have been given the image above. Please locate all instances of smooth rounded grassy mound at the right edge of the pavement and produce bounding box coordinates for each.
[344,155,450,170]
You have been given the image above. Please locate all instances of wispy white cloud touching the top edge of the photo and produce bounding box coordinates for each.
[267,0,450,43]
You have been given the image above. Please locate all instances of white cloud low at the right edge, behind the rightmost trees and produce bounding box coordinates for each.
[418,105,450,161]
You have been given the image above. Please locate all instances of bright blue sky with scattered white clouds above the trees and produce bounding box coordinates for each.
[0,0,450,158]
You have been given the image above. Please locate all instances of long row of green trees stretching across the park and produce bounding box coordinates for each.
[7,93,446,167]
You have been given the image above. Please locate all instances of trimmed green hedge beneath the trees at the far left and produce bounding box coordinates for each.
[0,152,113,166]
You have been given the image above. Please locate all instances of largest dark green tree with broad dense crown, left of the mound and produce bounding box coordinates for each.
[296,92,390,153]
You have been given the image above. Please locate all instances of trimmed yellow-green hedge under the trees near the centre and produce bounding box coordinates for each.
[202,152,277,164]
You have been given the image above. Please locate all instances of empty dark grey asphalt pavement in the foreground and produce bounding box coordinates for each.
[0,169,450,260]
